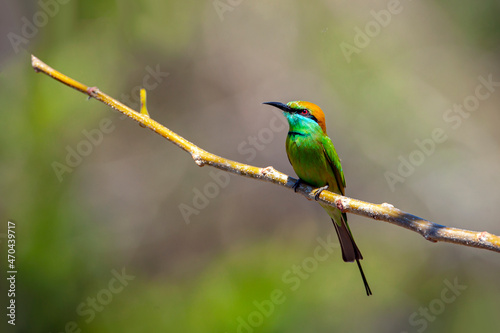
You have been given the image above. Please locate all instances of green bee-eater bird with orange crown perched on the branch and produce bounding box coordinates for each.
[263,101,372,296]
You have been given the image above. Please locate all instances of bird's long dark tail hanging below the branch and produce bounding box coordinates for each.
[332,212,372,296]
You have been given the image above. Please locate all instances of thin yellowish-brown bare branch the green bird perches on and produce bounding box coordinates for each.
[31,55,500,252]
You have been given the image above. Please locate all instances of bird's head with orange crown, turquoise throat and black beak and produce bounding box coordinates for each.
[263,101,326,134]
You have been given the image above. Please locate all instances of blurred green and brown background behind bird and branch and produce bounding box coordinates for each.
[0,0,500,333]
